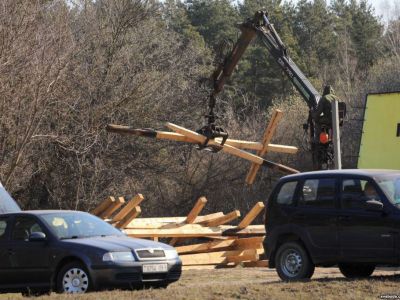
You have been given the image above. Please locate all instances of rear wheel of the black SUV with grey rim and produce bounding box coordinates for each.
[275,242,315,281]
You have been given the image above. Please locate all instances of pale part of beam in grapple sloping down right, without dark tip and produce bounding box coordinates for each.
[167,123,264,165]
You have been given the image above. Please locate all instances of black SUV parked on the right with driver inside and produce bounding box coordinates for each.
[264,170,400,280]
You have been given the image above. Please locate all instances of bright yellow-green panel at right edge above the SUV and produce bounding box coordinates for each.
[358,92,400,170]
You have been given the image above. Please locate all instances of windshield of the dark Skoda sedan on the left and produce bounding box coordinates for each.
[41,212,123,239]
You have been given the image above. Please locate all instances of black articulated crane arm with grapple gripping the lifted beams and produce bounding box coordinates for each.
[203,11,344,169]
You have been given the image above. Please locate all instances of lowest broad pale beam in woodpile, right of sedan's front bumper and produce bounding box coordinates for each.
[179,250,254,265]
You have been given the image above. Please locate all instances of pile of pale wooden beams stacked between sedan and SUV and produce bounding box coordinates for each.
[91,194,268,269]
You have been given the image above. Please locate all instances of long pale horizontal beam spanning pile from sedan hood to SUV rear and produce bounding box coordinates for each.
[125,224,265,237]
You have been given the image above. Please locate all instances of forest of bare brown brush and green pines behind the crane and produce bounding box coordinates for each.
[0,0,400,216]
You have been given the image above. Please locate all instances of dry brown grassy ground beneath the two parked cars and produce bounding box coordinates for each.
[4,268,400,300]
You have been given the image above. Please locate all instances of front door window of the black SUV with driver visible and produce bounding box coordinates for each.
[341,178,381,209]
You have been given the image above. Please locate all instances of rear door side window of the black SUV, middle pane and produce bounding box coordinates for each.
[299,178,335,207]
